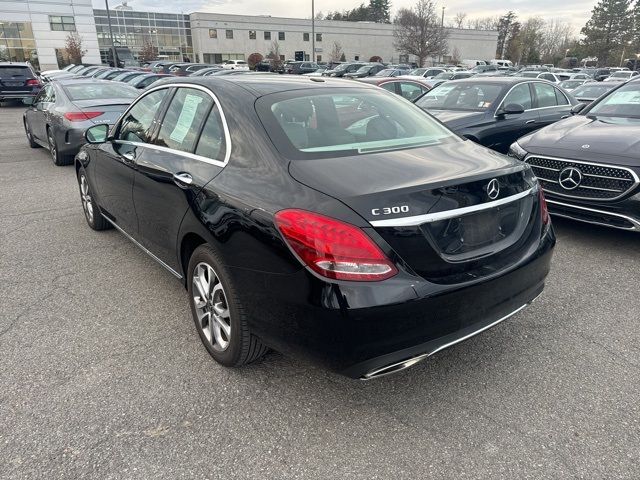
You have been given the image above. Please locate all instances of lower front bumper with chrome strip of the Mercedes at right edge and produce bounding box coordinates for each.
[547,194,640,232]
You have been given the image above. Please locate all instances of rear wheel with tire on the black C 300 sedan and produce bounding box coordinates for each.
[187,244,268,367]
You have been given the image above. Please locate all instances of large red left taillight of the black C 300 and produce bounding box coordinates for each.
[275,210,398,282]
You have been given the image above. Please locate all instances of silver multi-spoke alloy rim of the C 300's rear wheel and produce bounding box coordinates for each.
[191,262,231,351]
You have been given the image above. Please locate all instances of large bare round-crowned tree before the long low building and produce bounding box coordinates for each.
[393,0,447,67]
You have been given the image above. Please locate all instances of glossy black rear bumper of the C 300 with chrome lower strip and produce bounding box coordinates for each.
[231,229,555,378]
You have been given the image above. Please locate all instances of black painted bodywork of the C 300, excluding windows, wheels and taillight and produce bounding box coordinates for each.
[76,75,555,378]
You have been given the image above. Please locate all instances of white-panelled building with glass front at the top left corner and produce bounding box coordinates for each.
[0,0,100,70]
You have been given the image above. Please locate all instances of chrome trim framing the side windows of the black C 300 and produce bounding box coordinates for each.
[113,83,231,168]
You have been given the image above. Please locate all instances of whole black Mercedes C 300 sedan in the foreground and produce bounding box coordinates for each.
[76,75,555,378]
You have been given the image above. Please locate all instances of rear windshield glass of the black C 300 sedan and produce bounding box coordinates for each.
[258,88,457,159]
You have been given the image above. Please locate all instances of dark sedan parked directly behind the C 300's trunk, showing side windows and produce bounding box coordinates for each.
[415,77,578,153]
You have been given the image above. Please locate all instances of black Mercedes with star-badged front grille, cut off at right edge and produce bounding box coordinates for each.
[510,80,640,231]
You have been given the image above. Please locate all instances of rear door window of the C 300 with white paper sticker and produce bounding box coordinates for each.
[154,88,213,153]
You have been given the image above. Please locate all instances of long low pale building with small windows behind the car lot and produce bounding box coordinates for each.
[190,12,498,64]
